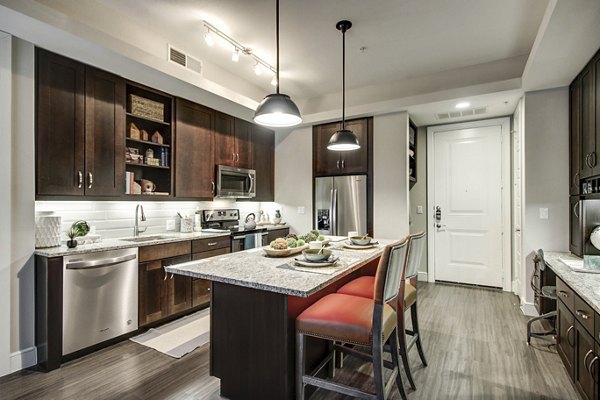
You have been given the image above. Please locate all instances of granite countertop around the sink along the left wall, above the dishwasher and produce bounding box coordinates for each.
[34,224,289,257]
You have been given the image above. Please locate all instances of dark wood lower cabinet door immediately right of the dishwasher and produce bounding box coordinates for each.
[138,260,167,326]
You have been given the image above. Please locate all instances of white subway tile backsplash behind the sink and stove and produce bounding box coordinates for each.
[35,200,285,240]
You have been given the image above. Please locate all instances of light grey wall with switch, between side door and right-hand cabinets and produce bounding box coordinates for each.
[521,87,569,304]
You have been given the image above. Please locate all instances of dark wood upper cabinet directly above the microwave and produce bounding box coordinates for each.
[215,112,253,168]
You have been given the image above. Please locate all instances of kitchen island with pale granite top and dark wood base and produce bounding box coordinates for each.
[166,238,391,400]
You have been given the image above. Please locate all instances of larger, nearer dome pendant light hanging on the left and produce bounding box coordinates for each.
[254,0,302,127]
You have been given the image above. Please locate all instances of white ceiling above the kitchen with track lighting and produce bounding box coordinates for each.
[0,0,600,125]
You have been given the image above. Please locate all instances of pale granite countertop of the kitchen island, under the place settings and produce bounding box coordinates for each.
[165,237,392,297]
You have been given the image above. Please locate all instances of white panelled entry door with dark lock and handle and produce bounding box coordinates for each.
[433,125,503,287]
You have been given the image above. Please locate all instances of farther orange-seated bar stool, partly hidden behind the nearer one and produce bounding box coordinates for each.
[337,232,427,390]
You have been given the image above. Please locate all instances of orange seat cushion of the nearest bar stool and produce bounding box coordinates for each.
[296,293,396,345]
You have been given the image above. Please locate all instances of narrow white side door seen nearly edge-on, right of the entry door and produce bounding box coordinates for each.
[512,99,523,295]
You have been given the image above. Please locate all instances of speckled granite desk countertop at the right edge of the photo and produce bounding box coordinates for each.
[544,252,600,314]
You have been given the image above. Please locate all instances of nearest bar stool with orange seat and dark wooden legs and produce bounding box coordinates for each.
[296,239,408,400]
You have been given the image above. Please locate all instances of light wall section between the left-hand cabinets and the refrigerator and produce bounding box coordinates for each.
[275,127,313,235]
